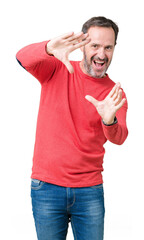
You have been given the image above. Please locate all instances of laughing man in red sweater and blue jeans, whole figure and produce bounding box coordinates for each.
[17,17,128,240]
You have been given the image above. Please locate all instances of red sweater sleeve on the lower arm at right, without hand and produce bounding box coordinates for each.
[102,92,128,145]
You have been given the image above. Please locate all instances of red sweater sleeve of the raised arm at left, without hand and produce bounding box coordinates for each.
[16,41,59,84]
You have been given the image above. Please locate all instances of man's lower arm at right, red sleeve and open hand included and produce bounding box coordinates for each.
[86,83,128,145]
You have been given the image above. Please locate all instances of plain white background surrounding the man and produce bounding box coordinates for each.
[0,0,144,240]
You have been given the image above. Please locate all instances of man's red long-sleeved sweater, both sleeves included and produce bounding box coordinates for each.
[16,42,128,187]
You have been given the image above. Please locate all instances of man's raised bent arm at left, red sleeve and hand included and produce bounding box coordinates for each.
[16,32,90,84]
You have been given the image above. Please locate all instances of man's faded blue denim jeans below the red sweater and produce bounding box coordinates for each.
[31,179,105,240]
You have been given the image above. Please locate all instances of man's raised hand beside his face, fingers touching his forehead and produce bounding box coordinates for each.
[47,32,90,73]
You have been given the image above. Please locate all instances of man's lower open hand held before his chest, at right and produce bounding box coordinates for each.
[85,83,126,124]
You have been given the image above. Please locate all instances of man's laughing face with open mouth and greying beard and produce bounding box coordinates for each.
[80,26,115,78]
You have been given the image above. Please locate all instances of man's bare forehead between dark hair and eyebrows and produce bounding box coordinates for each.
[88,26,115,45]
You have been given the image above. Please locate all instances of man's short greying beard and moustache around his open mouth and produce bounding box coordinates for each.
[83,49,111,78]
